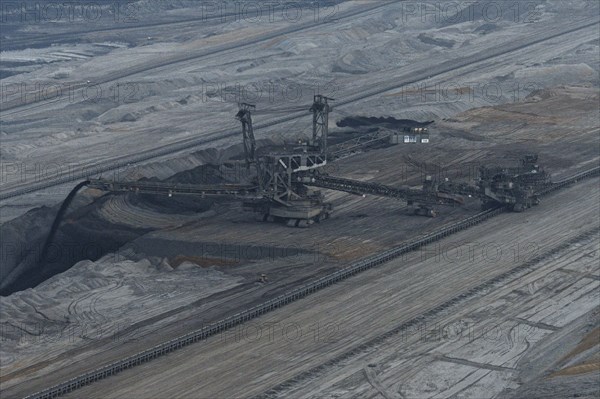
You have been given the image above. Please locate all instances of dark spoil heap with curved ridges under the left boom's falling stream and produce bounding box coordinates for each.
[0,160,240,295]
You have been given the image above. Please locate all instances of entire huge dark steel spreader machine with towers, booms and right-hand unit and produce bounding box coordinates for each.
[88,95,547,227]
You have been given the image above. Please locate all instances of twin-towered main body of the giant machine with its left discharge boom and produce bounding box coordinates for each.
[88,95,333,227]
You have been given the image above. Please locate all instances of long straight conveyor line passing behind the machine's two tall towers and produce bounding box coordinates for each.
[0,20,599,200]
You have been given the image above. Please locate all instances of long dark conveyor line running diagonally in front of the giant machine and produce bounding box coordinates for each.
[26,166,600,399]
